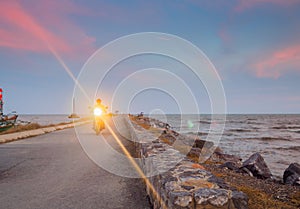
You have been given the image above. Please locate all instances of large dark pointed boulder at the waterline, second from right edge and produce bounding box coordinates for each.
[241,153,272,179]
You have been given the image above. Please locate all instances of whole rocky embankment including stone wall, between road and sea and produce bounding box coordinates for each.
[130,116,300,209]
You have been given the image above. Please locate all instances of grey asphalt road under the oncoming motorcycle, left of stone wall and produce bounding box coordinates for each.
[0,118,150,209]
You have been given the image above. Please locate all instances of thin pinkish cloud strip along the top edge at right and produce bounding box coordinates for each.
[234,0,300,12]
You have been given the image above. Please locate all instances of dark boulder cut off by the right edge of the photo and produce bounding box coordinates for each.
[283,163,300,186]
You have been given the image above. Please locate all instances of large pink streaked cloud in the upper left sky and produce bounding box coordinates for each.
[0,1,94,56]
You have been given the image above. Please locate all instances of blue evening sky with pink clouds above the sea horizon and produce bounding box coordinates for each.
[0,0,300,114]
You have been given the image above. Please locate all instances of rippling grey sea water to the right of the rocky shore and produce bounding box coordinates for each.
[151,114,300,178]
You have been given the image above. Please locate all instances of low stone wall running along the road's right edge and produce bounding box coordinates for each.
[128,116,248,209]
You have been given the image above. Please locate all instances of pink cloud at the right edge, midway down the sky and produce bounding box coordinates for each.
[254,45,300,79]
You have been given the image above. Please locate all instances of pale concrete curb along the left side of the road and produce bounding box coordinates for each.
[0,121,89,144]
